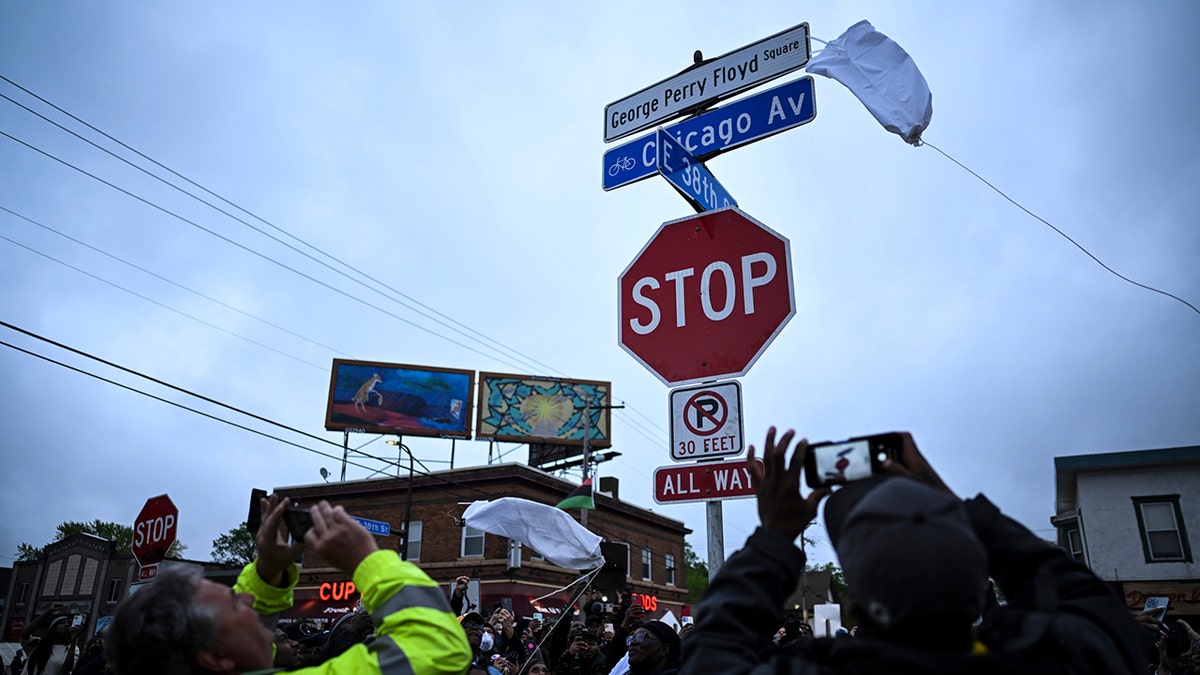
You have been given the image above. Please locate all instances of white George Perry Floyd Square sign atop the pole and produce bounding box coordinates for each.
[604,23,810,143]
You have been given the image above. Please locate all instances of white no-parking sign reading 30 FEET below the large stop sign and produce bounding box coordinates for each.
[668,380,744,461]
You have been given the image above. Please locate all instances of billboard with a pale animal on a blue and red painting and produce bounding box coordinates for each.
[325,359,475,438]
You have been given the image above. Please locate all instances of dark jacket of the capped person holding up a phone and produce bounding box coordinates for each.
[682,495,1146,675]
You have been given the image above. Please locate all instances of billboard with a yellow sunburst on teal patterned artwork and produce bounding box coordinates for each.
[475,372,612,448]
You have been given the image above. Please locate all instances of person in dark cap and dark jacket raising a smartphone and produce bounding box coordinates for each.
[683,428,1146,675]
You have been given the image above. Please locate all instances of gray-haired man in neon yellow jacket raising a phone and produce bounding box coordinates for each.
[104,495,470,675]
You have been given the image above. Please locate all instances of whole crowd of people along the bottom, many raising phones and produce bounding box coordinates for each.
[8,429,1200,675]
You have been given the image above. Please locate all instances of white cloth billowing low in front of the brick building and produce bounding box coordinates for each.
[462,497,604,569]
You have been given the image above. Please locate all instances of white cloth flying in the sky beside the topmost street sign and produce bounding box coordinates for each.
[804,20,934,145]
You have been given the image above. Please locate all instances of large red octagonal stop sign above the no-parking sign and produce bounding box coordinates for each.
[618,207,796,384]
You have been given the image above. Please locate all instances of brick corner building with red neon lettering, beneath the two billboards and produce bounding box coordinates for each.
[275,464,691,619]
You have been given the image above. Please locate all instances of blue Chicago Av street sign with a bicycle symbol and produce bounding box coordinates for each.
[601,76,817,191]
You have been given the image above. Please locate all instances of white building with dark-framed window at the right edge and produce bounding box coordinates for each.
[1051,446,1200,617]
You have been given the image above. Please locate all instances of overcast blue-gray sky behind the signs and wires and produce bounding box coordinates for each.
[0,0,1200,565]
